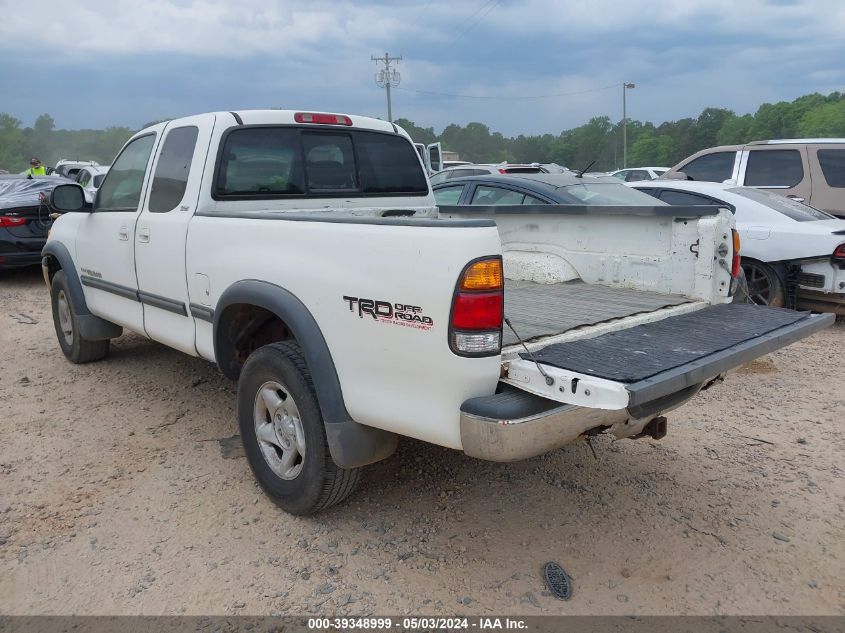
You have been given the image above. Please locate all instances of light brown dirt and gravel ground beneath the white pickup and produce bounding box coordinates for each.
[0,270,845,615]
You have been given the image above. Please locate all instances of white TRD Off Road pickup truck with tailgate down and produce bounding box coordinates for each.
[43,110,833,514]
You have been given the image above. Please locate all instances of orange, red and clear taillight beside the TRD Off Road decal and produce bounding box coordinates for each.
[449,257,505,356]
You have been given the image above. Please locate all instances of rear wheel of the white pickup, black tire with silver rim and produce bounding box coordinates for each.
[238,342,361,515]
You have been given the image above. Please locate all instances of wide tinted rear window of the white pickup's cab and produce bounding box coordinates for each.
[215,126,428,199]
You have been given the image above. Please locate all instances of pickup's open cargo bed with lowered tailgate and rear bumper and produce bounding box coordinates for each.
[440,202,833,461]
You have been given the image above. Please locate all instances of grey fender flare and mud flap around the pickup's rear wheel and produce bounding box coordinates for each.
[214,279,398,468]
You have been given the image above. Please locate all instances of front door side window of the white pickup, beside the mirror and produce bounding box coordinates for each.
[97,134,155,211]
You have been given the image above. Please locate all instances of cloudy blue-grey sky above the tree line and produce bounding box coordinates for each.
[0,0,845,136]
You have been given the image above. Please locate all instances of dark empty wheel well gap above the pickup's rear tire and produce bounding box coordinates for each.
[214,303,295,380]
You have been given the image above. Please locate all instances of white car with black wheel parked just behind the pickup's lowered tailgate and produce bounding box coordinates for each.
[631,180,845,315]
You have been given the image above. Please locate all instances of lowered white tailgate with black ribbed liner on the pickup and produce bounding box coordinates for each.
[502,303,835,409]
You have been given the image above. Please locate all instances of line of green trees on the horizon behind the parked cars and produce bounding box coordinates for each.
[0,92,845,173]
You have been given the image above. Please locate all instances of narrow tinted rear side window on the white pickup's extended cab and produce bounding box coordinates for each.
[149,125,199,213]
